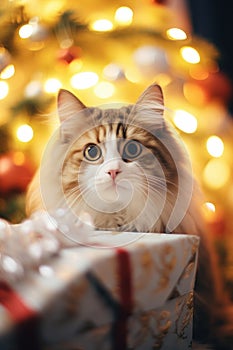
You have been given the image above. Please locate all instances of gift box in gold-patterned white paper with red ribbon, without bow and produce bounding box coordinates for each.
[0,232,199,350]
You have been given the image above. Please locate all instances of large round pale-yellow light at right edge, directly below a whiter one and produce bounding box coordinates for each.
[203,159,231,189]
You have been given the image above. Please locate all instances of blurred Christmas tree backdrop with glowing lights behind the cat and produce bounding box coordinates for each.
[0,0,233,296]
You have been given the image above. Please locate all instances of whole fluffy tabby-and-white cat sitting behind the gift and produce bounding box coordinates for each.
[26,84,233,350]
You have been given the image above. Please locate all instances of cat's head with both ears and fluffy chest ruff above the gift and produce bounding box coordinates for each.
[48,85,189,232]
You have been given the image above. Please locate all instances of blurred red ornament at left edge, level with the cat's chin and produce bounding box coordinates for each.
[0,152,35,194]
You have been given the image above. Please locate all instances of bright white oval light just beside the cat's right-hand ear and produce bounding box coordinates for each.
[173,109,197,134]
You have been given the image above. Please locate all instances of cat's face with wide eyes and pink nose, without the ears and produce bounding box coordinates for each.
[63,117,166,213]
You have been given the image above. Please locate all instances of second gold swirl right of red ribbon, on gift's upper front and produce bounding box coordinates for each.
[155,244,176,293]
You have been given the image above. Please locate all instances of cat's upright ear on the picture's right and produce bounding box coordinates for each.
[136,84,164,115]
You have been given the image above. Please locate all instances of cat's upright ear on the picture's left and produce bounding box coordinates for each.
[57,89,86,123]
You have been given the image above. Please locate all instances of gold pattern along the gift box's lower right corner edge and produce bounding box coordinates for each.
[175,292,193,338]
